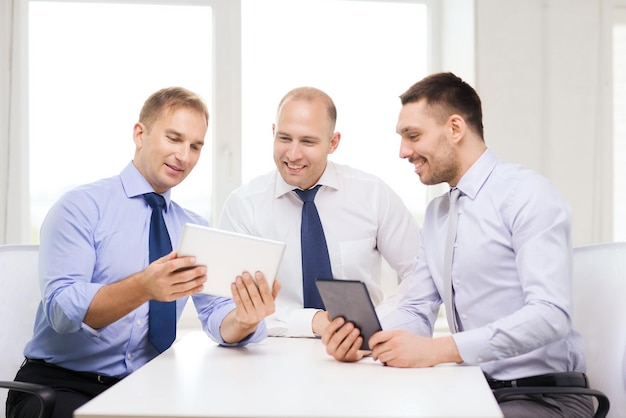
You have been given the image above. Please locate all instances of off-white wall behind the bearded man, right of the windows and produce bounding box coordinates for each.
[475,0,612,245]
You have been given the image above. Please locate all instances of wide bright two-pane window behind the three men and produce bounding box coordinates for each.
[28,0,429,242]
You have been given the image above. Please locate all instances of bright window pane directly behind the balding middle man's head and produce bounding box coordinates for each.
[242,0,429,219]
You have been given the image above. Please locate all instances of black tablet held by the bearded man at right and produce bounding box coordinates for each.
[315,279,382,350]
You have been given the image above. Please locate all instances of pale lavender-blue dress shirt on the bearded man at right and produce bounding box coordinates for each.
[382,150,585,380]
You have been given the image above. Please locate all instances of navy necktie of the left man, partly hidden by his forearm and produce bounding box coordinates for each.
[143,193,176,353]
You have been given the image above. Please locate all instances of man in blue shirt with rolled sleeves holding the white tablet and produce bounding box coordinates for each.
[7,87,280,418]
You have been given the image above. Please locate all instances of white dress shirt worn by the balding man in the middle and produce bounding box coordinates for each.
[219,161,420,337]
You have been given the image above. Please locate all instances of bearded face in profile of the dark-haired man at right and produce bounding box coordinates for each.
[396,100,460,185]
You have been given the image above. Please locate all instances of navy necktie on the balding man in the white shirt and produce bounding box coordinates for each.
[294,184,333,309]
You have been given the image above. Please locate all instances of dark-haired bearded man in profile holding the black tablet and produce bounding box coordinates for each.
[322,73,592,417]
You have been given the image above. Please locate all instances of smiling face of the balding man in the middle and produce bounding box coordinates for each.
[273,99,340,190]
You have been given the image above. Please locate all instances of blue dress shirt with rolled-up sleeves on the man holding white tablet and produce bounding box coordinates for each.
[24,162,267,377]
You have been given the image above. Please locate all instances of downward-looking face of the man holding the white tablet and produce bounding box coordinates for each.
[133,107,208,193]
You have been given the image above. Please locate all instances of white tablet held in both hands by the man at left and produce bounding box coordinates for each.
[177,223,285,297]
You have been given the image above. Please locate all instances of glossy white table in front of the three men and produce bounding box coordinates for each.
[74,331,502,418]
